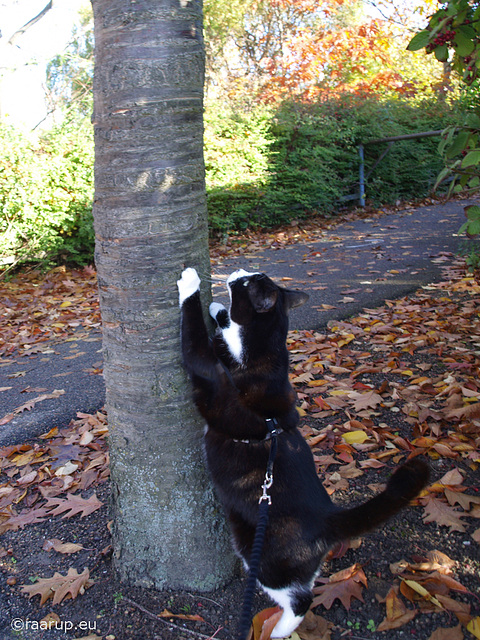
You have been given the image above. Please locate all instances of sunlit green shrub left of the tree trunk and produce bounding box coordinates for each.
[0,120,94,267]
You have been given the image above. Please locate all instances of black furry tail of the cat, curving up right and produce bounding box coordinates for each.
[327,458,430,544]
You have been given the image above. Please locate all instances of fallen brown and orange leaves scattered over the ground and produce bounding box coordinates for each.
[0,236,480,640]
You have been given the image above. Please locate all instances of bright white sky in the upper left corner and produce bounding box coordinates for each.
[0,0,89,130]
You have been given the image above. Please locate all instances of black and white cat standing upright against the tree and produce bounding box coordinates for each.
[178,268,429,638]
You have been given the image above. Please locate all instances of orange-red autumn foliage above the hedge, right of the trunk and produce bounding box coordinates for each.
[227,0,430,102]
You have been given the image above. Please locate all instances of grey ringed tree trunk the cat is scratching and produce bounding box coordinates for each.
[93,0,233,591]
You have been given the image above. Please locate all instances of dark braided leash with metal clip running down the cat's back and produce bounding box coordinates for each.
[238,418,282,640]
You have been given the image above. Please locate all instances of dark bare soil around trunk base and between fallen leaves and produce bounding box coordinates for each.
[0,205,480,640]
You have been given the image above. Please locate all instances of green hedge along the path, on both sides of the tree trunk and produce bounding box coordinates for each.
[0,96,462,267]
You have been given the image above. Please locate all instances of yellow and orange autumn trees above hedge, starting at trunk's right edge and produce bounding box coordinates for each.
[206,0,441,102]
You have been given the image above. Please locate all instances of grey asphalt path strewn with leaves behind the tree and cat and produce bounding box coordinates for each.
[0,201,469,446]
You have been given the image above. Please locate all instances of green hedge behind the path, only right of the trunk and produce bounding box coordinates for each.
[206,95,456,234]
